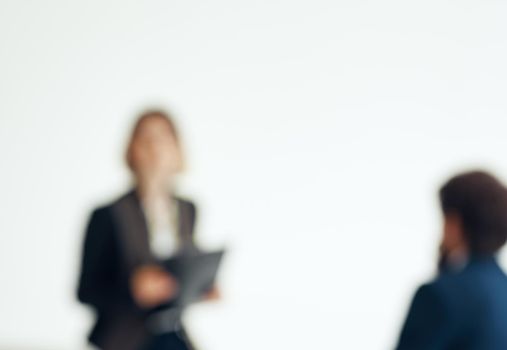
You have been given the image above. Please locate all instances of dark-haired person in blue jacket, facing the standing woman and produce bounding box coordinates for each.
[396,171,507,350]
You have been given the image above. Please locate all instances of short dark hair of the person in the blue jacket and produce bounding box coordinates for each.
[440,171,507,255]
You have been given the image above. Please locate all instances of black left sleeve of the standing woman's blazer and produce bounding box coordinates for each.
[77,208,119,310]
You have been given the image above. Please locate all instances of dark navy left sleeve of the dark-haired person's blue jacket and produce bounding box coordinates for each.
[396,284,453,350]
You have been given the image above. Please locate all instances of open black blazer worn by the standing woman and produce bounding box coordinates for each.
[77,191,196,350]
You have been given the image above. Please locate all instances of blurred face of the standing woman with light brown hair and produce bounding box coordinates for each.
[130,116,182,180]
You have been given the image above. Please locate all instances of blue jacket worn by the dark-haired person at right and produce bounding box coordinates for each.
[396,257,507,350]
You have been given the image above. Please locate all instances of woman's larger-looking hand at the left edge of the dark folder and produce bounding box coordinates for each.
[130,265,178,309]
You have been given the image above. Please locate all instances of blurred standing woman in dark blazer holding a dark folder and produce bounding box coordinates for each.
[78,110,216,350]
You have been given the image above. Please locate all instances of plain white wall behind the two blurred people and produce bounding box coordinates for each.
[0,0,507,350]
